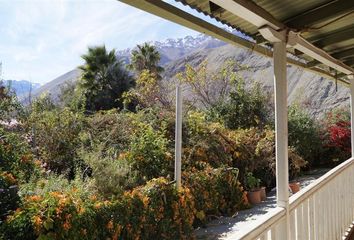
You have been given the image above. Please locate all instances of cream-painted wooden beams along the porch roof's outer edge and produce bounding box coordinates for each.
[120,0,354,84]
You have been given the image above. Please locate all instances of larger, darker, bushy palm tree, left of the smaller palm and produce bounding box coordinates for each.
[79,46,134,111]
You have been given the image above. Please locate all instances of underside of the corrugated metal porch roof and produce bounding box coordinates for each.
[176,0,354,70]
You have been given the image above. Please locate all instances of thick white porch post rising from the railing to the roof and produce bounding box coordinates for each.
[273,41,290,240]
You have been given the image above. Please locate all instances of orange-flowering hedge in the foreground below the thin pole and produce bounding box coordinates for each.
[0,178,194,239]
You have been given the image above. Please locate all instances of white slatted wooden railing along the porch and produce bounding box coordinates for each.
[236,158,354,240]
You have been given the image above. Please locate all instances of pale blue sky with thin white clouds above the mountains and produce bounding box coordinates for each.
[0,0,225,84]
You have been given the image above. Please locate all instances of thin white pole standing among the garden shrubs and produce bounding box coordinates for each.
[175,84,182,189]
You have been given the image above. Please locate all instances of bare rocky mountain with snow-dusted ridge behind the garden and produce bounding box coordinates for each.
[29,34,349,117]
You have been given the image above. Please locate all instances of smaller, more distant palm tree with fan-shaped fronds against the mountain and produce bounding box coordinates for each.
[129,43,164,75]
